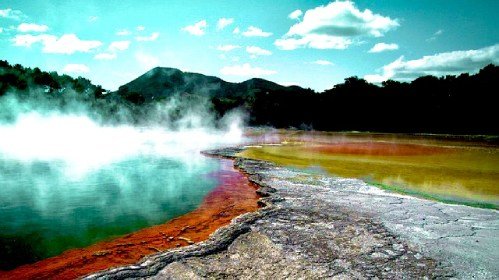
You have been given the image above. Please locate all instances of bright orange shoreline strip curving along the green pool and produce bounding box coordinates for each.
[0,159,259,279]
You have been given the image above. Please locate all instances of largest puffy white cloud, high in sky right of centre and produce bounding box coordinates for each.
[275,1,399,50]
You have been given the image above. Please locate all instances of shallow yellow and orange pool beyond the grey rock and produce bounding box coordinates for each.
[240,130,499,209]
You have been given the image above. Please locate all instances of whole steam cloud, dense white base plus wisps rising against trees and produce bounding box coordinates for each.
[0,86,244,178]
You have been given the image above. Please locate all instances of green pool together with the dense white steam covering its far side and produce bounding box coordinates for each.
[0,113,244,272]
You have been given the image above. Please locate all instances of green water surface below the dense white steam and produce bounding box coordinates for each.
[0,156,219,269]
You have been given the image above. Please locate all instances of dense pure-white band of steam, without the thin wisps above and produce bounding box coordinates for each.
[0,113,242,176]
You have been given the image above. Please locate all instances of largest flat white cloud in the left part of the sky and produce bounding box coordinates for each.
[11,34,102,54]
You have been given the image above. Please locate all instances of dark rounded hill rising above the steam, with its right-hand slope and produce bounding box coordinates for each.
[112,67,315,124]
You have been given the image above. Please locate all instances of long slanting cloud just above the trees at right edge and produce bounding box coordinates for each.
[364,44,499,83]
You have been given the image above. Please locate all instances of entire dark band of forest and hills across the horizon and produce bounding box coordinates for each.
[0,61,499,135]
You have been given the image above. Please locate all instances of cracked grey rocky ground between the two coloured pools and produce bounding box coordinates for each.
[87,149,499,279]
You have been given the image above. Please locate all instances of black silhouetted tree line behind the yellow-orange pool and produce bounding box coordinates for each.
[241,65,499,135]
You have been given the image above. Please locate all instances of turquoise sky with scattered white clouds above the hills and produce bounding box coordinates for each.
[0,0,499,91]
